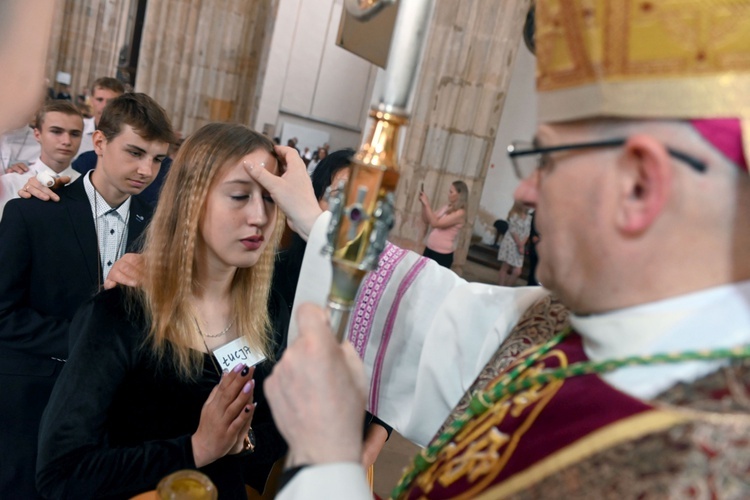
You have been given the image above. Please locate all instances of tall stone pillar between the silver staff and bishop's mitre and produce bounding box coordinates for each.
[391,0,530,271]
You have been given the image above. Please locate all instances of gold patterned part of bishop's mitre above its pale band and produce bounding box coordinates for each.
[537,0,750,91]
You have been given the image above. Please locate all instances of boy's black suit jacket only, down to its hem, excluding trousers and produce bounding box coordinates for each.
[0,176,151,369]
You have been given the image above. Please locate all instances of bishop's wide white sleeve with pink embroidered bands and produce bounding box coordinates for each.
[289,212,548,446]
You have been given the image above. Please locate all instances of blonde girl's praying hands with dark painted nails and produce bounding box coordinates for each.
[191,364,255,467]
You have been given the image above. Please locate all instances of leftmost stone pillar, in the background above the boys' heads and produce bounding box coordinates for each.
[47,0,136,97]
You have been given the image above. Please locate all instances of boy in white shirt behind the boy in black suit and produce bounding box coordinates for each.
[0,100,83,218]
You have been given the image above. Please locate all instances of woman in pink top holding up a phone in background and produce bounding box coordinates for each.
[419,181,469,269]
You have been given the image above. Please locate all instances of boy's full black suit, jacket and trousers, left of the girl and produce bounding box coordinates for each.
[0,176,151,498]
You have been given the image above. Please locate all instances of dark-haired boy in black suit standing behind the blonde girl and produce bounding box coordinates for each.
[0,94,174,498]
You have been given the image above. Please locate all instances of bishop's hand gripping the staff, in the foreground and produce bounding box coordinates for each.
[264,304,367,466]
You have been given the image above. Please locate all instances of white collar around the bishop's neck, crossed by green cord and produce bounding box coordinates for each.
[570,281,750,399]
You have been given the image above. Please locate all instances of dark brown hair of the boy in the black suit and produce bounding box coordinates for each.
[98,92,176,144]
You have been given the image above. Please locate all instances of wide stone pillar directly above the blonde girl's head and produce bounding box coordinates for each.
[136,0,278,135]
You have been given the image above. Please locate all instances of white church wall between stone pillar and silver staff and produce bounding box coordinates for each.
[254,0,376,150]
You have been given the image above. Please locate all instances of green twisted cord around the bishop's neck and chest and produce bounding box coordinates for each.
[391,327,750,498]
